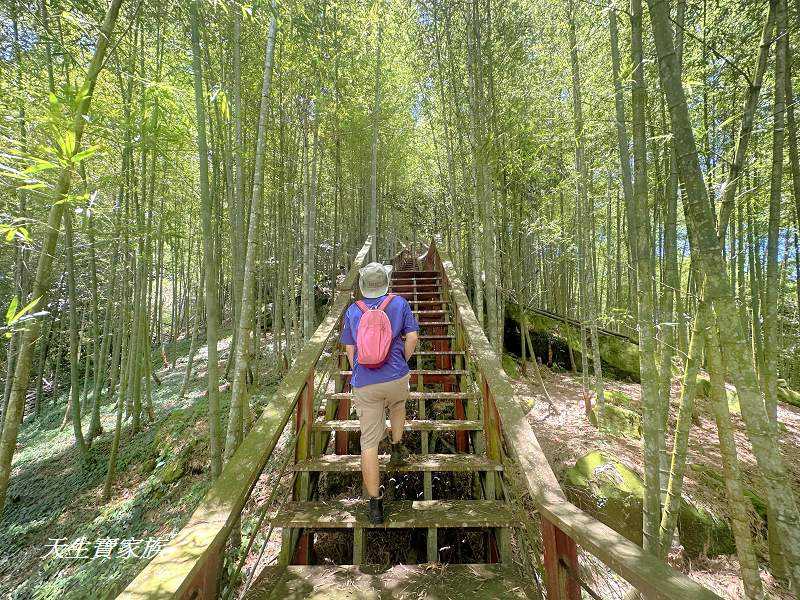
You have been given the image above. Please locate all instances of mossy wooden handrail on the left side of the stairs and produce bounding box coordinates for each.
[118,238,372,600]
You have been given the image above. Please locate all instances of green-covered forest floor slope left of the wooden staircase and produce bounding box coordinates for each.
[0,338,272,600]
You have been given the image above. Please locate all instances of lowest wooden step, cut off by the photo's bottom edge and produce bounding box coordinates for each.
[244,563,536,600]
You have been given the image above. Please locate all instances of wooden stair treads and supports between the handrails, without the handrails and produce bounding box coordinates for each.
[246,261,527,599]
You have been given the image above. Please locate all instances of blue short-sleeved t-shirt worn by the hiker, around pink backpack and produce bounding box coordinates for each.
[340,296,419,387]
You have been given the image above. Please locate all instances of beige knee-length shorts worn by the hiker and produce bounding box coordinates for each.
[353,374,410,450]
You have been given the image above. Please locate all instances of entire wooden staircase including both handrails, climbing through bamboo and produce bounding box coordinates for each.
[118,238,720,600]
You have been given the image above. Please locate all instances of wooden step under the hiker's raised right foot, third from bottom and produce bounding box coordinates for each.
[293,454,503,473]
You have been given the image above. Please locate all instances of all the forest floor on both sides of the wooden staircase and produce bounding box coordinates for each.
[0,338,800,600]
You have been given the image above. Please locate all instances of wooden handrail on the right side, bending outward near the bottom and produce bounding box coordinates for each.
[429,242,720,600]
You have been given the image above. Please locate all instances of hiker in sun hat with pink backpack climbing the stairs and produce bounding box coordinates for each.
[341,262,419,524]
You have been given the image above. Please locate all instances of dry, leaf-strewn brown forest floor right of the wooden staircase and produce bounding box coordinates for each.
[516,363,800,600]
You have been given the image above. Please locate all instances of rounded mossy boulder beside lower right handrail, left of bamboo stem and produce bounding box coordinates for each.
[565,450,644,545]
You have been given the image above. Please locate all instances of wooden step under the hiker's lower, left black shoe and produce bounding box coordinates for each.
[270,499,515,529]
